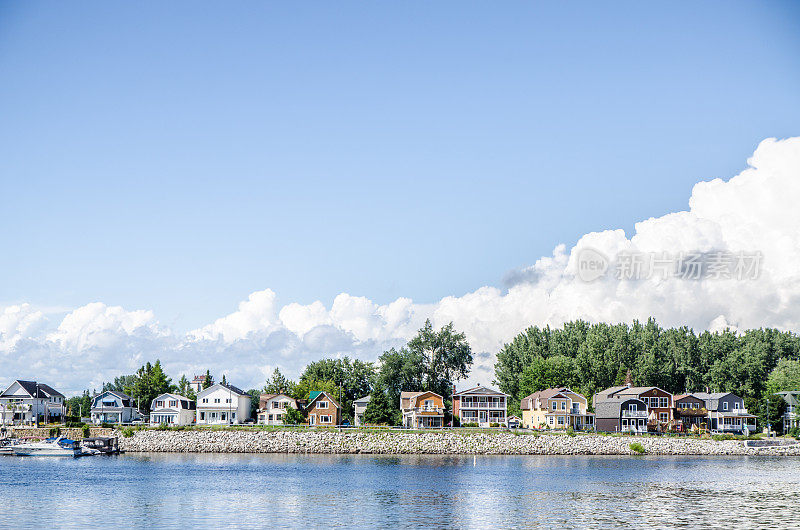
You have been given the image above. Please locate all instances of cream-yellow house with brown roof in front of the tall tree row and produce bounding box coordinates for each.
[520,387,594,430]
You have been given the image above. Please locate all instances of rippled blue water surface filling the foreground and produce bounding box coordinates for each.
[0,453,800,528]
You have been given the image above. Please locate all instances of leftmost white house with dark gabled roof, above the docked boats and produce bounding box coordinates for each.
[0,379,66,425]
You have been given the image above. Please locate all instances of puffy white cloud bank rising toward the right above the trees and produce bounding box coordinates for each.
[0,138,800,393]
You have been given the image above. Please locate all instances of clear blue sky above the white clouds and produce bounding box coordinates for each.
[0,2,800,331]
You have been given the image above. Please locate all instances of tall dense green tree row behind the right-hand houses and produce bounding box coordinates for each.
[494,318,800,423]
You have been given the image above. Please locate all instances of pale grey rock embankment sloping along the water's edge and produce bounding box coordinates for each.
[119,429,800,456]
